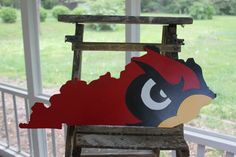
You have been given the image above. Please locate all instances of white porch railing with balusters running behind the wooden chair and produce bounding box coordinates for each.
[0,84,236,157]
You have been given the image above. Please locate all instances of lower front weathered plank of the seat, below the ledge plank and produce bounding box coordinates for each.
[75,133,187,150]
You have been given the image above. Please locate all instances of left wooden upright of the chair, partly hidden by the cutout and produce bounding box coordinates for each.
[65,23,84,157]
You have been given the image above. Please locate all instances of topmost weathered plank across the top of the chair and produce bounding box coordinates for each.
[58,15,193,25]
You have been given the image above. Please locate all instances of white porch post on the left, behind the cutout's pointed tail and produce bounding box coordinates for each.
[21,0,47,157]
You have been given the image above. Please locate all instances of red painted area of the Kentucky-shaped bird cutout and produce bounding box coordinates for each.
[19,49,214,128]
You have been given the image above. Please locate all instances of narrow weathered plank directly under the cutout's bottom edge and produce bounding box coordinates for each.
[76,125,183,136]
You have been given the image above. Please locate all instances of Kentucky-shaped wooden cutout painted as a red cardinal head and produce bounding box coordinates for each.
[19,47,215,128]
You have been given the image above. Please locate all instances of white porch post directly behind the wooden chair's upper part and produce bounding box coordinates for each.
[125,0,141,64]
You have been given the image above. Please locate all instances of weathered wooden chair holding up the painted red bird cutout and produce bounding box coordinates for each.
[58,15,193,157]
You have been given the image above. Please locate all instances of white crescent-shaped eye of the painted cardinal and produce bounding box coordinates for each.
[141,79,171,110]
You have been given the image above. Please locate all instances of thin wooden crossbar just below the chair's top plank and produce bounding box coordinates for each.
[72,42,181,52]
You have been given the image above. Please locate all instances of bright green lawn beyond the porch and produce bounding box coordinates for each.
[0,10,236,135]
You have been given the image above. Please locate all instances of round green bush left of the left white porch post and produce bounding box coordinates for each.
[0,7,17,23]
